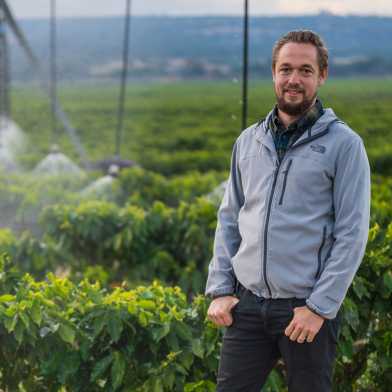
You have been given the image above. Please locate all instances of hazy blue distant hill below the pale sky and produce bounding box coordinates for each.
[11,13,392,81]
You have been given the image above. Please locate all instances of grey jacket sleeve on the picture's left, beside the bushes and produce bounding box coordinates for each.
[205,139,244,298]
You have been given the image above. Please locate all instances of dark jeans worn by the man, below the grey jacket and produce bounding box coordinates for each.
[217,288,340,392]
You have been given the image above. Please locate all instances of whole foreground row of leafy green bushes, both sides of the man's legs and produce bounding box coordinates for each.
[0,236,392,392]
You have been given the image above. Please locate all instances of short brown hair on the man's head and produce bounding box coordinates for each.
[272,30,328,72]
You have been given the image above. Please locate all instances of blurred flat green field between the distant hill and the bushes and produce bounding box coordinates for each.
[13,80,392,175]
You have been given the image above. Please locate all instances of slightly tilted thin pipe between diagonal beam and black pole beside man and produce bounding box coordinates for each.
[115,0,131,158]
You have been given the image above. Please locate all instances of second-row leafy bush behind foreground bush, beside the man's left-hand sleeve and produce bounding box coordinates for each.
[43,198,216,292]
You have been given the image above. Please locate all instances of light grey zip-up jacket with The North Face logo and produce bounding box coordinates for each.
[206,109,370,319]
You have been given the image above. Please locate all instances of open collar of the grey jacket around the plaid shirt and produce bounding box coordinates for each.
[254,108,338,151]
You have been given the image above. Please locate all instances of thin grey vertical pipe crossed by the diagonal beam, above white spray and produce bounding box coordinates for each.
[50,0,58,144]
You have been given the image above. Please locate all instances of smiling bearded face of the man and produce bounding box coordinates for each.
[272,42,327,116]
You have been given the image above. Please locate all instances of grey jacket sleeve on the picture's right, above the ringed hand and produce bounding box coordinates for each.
[306,137,370,319]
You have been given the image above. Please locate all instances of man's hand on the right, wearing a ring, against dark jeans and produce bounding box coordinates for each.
[284,306,324,343]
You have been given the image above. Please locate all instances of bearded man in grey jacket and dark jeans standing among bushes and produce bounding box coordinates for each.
[206,31,370,392]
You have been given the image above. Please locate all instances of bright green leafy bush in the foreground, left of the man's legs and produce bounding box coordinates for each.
[0,258,220,392]
